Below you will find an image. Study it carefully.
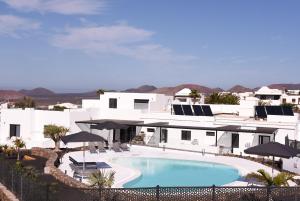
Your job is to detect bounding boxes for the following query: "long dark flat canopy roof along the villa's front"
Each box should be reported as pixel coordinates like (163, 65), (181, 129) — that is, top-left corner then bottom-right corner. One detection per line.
(76, 119), (278, 134)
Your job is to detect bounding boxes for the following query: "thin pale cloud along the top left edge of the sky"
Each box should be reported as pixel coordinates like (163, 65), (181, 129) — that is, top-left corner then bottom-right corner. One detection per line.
(0, 0), (105, 15)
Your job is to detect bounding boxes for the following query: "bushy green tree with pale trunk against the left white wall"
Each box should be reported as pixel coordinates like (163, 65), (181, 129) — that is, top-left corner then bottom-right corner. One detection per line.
(44, 124), (69, 151)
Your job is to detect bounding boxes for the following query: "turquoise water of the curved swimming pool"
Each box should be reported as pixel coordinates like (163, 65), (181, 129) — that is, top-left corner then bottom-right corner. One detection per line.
(113, 158), (240, 188)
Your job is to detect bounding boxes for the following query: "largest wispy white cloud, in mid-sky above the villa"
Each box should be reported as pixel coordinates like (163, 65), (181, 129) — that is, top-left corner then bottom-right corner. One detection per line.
(50, 24), (195, 62)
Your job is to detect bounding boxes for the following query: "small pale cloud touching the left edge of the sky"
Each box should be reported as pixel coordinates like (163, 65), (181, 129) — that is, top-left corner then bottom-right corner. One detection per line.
(0, 15), (40, 38)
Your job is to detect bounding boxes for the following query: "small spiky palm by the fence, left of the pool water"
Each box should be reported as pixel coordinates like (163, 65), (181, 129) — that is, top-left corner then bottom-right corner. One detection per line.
(89, 170), (116, 189)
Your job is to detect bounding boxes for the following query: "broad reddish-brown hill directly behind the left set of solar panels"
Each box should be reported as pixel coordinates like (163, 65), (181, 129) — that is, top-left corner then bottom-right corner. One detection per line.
(152, 84), (222, 95)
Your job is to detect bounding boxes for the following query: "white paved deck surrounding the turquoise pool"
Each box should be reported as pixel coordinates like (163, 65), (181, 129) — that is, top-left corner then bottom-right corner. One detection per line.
(59, 146), (278, 188)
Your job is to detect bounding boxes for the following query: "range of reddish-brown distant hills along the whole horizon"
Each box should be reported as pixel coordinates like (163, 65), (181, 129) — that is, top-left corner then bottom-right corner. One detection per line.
(0, 84), (300, 106)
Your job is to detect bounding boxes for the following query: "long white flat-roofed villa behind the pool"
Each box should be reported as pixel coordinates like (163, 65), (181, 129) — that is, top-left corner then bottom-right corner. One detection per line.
(0, 89), (300, 174)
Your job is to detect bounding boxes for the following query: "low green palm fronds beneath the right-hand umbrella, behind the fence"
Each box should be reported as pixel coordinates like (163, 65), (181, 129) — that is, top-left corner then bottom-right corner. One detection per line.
(246, 169), (293, 186)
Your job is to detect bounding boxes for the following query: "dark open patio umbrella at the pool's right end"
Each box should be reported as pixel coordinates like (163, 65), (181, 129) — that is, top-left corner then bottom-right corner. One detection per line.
(244, 142), (299, 177)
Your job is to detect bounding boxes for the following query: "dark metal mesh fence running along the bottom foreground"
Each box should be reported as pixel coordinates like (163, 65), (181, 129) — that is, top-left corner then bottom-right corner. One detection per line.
(0, 161), (300, 201)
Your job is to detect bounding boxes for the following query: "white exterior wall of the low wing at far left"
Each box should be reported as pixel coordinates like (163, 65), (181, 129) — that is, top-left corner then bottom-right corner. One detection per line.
(0, 108), (89, 148)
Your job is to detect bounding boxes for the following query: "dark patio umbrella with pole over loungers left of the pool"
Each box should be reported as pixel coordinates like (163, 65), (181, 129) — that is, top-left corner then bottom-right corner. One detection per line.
(61, 131), (105, 181)
